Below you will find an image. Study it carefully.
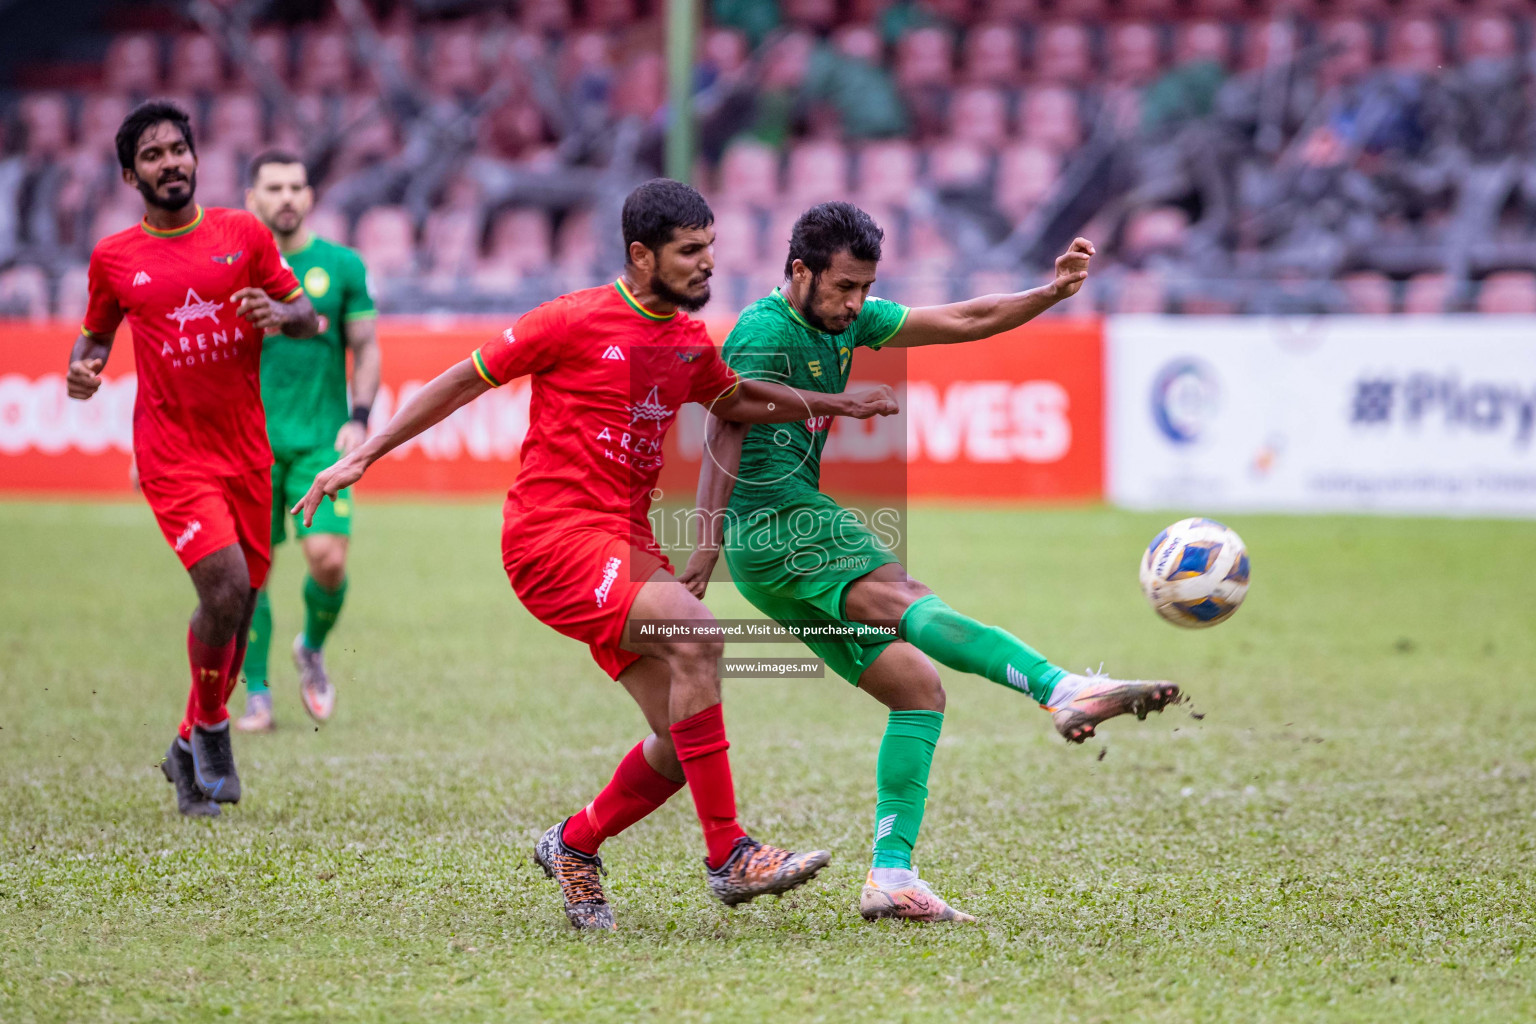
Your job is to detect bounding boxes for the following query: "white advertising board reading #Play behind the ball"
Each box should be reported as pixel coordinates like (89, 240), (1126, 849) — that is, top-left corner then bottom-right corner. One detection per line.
(1106, 316), (1536, 516)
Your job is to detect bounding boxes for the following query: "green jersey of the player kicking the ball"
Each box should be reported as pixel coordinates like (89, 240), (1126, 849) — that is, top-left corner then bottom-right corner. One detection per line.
(720, 289), (908, 517)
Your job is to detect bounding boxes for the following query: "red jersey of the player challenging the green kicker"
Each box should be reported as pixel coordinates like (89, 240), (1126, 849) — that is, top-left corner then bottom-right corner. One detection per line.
(473, 281), (737, 536)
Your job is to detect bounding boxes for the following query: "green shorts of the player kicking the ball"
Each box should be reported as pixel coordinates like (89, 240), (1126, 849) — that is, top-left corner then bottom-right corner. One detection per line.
(723, 493), (899, 686)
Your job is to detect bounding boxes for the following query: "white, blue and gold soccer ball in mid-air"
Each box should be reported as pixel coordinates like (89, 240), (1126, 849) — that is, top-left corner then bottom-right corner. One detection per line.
(1141, 519), (1249, 629)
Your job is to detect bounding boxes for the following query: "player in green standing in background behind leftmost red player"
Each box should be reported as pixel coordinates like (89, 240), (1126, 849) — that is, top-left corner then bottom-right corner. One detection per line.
(235, 150), (379, 732)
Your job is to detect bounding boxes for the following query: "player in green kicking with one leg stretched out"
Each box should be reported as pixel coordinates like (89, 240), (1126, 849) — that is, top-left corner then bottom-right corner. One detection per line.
(691, 203), (1178, 921)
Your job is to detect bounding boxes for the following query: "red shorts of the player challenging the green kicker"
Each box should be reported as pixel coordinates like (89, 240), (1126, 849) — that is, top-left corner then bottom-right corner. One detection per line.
(501, 519), (673, 679)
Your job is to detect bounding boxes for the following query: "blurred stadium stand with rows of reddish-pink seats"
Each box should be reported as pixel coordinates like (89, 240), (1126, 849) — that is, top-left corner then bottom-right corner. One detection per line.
(0, 0), (1536, 318)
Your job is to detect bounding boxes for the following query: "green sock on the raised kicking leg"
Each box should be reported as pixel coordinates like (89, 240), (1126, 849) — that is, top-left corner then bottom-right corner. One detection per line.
(900, 594), (1066, 703)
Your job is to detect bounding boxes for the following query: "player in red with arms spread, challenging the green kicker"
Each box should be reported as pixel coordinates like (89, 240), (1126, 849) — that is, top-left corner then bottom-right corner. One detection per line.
(295, 178), (895, 929)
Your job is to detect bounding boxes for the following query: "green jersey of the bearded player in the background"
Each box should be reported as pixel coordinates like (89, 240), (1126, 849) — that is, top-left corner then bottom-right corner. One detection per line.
(261, 235), (375, 451)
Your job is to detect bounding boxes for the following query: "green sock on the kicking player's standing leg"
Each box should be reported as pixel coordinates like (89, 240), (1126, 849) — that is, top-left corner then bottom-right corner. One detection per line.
(869, 711), (945, 867)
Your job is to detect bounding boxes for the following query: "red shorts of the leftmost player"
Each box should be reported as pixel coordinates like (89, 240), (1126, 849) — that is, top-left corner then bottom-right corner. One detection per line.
(140, 468), (272, 586)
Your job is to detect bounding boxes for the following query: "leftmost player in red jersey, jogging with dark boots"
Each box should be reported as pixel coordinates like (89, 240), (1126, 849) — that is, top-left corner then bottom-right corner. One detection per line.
(68, 103), (319, 817)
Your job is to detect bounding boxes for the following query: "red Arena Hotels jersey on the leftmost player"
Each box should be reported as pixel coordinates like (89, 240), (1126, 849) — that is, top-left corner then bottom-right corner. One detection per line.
(81, 207), (303, 479)
